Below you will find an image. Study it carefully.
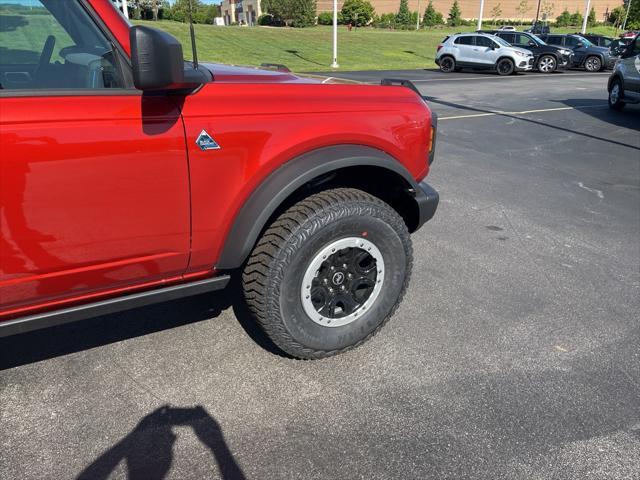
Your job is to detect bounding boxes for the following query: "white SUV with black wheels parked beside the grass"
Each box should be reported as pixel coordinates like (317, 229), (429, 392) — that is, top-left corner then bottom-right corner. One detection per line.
(436, 33), (533, 75)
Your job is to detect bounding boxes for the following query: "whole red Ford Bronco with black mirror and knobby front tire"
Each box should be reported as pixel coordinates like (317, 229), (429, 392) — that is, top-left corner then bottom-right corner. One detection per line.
(0, 0), (438, 358)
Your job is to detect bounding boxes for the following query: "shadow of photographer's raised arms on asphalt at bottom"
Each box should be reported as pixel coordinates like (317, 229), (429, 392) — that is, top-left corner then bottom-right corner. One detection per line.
(76, 405), (246, 480)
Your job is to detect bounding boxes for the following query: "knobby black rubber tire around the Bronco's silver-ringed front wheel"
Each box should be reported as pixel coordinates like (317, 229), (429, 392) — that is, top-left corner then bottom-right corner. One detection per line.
(242, 188), (413, 359)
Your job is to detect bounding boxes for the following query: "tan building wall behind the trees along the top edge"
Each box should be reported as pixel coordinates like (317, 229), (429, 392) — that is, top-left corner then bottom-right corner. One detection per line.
(317, 0), (622, 23)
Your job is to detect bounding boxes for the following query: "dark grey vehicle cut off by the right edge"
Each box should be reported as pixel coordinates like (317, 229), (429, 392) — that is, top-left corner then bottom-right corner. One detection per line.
(608, 35), (640, 110)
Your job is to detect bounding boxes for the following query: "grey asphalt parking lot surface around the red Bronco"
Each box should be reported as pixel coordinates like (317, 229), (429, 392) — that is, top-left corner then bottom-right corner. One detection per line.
(0, 71), (640, 480)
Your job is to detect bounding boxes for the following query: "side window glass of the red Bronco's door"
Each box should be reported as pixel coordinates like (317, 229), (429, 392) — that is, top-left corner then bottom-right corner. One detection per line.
(0, 0), (123, 90)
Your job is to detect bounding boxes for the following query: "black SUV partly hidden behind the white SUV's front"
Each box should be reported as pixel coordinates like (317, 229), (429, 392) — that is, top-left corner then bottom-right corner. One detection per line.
(481, 30), (573, 73)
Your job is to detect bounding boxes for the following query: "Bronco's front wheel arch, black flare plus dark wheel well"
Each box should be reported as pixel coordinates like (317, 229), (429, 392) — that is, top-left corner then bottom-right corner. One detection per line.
(216, 145), (427, 270)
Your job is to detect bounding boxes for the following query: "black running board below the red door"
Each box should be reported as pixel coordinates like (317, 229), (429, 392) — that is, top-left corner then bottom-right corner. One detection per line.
(0, 275), (230, 337)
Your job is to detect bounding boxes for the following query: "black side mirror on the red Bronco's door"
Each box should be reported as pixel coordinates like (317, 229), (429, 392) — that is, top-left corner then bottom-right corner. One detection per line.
(129, 25), (198, 91)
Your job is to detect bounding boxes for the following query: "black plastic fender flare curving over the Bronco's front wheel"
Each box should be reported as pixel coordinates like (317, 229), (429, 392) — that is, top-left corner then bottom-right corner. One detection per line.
(216, 145), (420, 270)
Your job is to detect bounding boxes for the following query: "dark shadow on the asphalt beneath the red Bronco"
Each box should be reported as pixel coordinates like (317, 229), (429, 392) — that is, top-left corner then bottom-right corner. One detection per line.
(0, 282), (284, 371)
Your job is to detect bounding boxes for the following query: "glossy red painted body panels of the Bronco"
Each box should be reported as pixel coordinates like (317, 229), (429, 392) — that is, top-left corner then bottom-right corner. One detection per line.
(0, 0), (431, 318)
